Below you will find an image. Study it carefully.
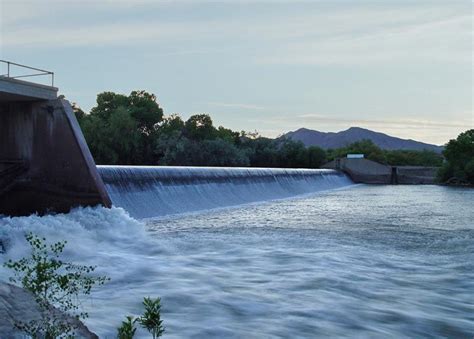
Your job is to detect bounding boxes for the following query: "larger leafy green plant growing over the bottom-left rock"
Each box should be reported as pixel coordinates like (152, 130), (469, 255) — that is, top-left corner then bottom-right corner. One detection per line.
(4, 233), (110, 339)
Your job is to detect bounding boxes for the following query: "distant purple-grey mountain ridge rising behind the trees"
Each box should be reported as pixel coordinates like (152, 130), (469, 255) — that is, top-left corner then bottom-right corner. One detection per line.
(284, 127), (443, 153)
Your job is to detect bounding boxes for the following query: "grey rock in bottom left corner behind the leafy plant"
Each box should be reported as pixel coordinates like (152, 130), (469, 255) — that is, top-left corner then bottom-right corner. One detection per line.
(0, 281), (98, 339)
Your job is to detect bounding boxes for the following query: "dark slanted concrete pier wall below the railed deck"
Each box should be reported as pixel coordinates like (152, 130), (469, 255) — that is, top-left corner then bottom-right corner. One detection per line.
(0, 99), (111, 215)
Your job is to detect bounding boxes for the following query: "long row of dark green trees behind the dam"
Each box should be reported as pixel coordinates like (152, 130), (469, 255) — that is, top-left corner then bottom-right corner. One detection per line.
(73, 91), (473, 185)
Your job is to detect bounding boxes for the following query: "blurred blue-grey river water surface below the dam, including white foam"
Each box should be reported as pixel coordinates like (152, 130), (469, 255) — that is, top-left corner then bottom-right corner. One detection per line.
(0, 185), (474, 338)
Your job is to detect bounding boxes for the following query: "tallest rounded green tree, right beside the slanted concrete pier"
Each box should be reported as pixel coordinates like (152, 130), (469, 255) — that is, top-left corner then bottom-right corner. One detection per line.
(79, 91), (163, 165)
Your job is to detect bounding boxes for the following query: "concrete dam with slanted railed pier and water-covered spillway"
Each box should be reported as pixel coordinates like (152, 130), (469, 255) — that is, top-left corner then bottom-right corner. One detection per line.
(0, 60), (352, 218)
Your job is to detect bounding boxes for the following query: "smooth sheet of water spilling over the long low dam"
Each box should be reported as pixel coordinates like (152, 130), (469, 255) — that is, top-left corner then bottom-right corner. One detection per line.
(97, 166), (353, 218)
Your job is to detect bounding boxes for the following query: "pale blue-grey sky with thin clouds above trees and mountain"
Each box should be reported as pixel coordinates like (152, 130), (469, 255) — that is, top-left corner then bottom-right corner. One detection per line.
(0, 0), (474, 144)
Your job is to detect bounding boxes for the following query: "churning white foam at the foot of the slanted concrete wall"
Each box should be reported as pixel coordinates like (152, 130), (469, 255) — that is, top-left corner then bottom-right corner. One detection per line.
(0, 207), (150, 280)
